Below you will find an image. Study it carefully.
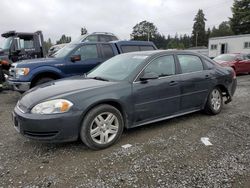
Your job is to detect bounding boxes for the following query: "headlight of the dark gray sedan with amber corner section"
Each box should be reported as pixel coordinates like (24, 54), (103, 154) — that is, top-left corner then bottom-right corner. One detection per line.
(31, 99), (73, 114)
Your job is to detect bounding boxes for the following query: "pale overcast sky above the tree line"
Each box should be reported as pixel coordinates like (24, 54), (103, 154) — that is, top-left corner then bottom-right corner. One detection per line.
(0, 0), (233, 42)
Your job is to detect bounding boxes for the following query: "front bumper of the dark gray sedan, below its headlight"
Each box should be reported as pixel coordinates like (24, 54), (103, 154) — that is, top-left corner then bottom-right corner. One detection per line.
(12, 107), (81, 142)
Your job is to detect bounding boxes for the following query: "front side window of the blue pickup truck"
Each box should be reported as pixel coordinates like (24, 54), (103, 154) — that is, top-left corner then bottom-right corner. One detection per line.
(74, 44), (98, 60)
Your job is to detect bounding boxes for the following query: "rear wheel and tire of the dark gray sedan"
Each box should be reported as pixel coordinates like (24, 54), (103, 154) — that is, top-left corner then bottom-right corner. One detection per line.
(204, 87), (223, 115)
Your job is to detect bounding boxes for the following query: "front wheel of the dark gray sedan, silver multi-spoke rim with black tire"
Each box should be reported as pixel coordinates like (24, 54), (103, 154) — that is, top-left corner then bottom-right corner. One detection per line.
(80, 104), (124, 150)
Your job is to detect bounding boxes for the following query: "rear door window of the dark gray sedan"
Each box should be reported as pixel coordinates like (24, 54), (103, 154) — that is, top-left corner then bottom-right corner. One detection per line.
(177, 55), (203, 73)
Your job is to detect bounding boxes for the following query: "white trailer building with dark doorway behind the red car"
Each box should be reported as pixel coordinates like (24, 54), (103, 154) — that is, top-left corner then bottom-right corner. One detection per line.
(208, 34), (250, 58)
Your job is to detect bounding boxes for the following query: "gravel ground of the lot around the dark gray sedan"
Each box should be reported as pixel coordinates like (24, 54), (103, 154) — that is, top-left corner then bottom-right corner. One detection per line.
(0, 75), (250, 188)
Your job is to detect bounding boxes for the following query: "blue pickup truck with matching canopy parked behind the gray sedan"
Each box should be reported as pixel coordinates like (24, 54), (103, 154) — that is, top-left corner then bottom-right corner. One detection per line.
(8, 41), (157, 92)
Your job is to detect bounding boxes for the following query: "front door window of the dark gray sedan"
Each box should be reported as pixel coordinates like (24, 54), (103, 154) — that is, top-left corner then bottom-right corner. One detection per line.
(144, 55), (175, 77)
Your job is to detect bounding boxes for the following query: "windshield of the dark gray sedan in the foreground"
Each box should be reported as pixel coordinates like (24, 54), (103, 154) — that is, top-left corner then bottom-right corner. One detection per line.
(87, 54), (148, 81)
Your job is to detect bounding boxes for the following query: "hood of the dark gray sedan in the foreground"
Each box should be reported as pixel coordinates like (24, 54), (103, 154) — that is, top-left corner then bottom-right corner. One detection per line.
(19, 76), (116, 108)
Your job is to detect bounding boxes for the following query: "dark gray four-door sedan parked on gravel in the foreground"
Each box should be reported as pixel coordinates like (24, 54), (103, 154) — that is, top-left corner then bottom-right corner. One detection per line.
(13, 51), (236, 149)
